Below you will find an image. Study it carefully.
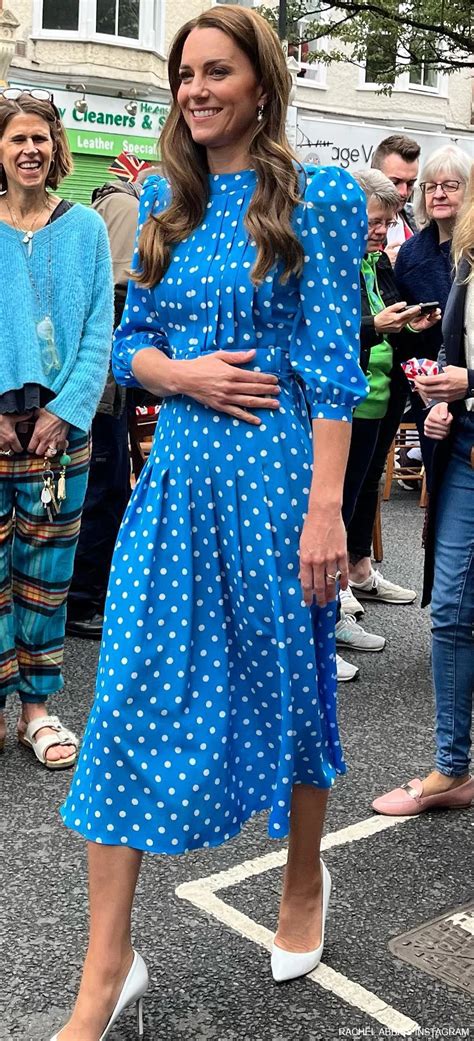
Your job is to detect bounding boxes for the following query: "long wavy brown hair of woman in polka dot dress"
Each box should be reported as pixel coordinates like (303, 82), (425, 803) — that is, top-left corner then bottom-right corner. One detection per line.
(136, 5), (304, 287)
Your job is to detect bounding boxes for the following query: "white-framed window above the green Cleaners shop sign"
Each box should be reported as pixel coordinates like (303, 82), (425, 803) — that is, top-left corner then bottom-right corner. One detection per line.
(33, 0), (165, 50)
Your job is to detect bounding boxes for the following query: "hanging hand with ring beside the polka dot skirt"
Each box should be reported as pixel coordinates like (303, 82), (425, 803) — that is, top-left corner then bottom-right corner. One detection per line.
(299, 507), (349, 607)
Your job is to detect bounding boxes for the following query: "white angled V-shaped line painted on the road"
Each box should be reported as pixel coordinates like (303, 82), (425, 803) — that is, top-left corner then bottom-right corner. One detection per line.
(176, 816), (420, 1037)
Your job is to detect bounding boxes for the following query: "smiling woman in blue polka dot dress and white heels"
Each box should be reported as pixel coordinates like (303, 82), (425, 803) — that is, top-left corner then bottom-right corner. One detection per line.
(55, 6), (367, 1041)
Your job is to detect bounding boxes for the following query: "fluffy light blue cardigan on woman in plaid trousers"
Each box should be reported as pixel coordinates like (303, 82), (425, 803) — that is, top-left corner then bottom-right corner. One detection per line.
(0, 204), (114, 431)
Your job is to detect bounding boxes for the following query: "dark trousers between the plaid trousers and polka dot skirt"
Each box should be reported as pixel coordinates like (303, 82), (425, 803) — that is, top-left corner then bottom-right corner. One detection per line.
(68, 410), (130, 621)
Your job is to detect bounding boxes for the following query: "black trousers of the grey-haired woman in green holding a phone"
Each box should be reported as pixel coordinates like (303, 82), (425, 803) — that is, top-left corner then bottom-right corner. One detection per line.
(347, 363), (408, 563)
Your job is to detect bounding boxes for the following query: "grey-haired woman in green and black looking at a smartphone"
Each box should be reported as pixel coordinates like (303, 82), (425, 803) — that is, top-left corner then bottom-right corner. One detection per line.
(336, 170), (441, 641)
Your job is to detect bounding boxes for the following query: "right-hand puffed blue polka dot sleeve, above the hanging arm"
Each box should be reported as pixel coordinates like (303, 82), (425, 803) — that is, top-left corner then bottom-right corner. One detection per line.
(291, 167), (369, 423)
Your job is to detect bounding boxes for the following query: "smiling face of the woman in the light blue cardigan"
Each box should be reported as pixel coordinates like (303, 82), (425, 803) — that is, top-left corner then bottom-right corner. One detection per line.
(0, 112), (54, 191)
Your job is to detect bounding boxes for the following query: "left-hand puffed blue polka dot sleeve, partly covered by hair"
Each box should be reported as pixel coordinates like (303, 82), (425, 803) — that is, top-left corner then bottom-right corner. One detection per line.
(111, 177), (170, 387)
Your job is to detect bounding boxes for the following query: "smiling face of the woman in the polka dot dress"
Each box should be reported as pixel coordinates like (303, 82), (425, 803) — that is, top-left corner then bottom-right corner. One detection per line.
(178, 29), (266, 164)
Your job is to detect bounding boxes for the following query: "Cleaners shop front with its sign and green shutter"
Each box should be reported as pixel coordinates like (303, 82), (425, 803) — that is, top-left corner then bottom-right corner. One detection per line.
(10, 82), (169, 204)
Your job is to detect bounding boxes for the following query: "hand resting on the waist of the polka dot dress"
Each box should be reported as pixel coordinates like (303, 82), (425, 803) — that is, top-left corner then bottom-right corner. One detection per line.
(178, 350), (279, 427)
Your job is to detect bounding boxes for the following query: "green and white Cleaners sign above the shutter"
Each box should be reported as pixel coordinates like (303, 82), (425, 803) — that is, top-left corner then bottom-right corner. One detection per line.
(10, 83), (169, 160)
